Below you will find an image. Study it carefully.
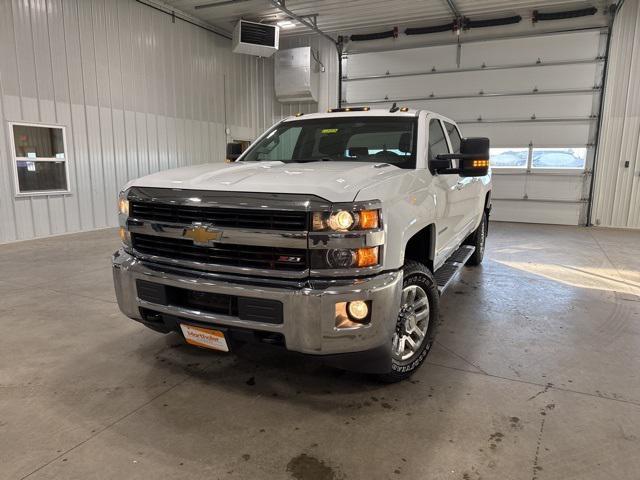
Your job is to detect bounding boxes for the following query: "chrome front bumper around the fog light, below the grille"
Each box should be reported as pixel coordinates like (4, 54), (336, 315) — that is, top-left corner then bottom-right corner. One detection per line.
(113, 249), (402, 365)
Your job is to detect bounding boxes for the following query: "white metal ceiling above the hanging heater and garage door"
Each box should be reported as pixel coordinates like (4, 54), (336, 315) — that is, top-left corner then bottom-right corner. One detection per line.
(158, 0), (610, 36)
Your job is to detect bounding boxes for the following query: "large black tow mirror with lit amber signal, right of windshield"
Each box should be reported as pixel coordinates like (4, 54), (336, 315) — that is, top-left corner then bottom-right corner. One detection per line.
(431, 137), (489, 177)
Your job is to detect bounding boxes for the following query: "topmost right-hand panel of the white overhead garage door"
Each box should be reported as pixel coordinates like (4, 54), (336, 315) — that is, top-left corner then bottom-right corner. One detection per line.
(460, 31), (601, 68)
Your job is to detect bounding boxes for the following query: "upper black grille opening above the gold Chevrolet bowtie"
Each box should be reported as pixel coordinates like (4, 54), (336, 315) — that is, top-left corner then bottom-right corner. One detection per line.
(129, 201), (308, 231)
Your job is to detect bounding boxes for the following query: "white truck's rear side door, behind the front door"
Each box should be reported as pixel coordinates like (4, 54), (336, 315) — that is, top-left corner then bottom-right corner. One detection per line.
(442, 121), (484, 243)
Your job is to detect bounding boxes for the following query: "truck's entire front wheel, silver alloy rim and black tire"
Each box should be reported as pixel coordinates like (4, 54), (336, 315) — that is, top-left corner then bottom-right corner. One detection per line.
(381, 260), (439, 383)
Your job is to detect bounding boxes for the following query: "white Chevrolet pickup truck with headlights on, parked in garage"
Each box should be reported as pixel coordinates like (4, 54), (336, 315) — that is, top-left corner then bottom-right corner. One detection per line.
(113, 105), (491, 381)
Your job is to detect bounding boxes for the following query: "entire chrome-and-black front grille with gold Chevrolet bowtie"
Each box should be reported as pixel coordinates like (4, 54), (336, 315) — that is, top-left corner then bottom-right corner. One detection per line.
(125, 187), (331, 279)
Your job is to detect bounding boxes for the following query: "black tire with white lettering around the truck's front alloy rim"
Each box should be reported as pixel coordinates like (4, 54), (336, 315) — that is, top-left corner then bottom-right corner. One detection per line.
(379, 260), (440, 383)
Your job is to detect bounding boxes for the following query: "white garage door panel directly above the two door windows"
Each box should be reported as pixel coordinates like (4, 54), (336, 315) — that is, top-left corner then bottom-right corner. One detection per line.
(460, 122), (592, 148)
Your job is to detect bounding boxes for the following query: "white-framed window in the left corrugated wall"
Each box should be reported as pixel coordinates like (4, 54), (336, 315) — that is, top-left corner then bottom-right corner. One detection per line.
(10, 123), (69, 195)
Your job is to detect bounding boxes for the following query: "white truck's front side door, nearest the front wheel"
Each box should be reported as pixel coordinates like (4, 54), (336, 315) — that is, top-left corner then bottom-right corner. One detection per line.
(427, 118), (465, 266)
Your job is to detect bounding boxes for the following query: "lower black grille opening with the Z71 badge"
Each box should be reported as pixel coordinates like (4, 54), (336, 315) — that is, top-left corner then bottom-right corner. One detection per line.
(131, 233), (309, 272)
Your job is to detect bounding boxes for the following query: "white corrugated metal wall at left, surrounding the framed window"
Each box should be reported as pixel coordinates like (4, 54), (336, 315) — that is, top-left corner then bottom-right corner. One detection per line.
(0, 0), (281, 243)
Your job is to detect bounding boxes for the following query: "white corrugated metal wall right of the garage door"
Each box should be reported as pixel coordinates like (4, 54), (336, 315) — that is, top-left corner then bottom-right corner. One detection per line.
(591, 0), (640, 228)
